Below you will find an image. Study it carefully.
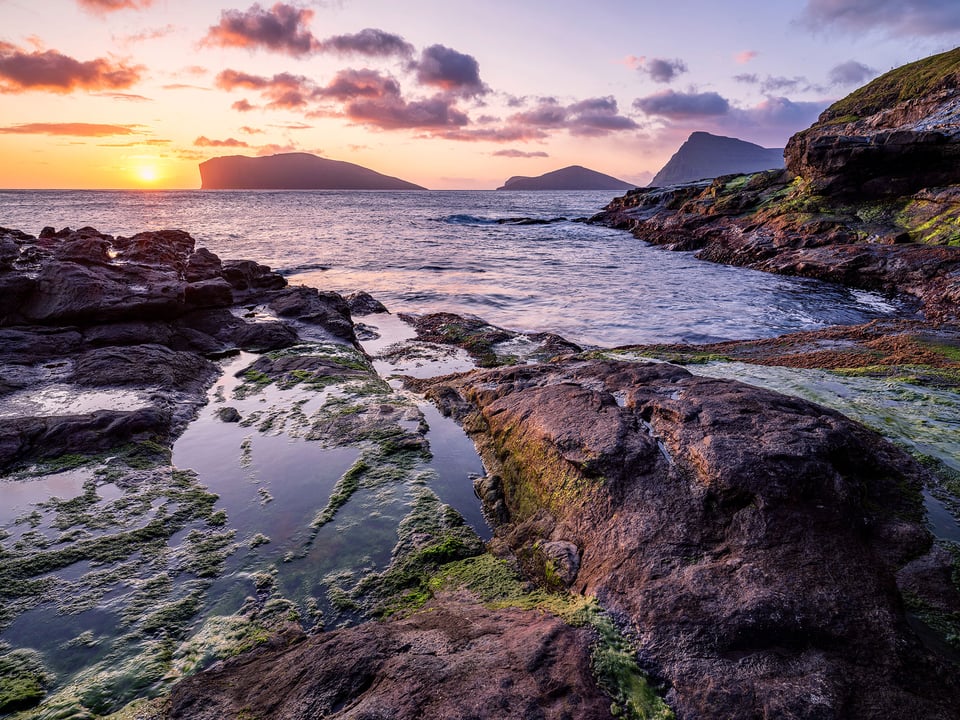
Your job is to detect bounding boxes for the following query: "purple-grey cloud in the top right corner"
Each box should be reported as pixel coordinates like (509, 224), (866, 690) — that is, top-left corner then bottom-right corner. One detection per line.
(801, 0), (960, 37)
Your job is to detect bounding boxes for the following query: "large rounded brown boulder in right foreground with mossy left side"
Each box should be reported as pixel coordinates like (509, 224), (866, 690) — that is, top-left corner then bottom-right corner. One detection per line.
(429, 360), (960, 720)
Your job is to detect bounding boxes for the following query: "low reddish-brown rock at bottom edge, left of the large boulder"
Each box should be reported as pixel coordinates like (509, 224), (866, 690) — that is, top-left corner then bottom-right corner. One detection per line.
(168, 593), (612, 720)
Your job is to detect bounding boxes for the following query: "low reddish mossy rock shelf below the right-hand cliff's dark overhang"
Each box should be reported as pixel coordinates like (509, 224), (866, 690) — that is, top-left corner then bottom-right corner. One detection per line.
(592, 171), (960, 323)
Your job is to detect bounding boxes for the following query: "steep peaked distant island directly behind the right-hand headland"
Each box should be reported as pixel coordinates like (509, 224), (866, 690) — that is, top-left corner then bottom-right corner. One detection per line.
(650, 132), (784, 187)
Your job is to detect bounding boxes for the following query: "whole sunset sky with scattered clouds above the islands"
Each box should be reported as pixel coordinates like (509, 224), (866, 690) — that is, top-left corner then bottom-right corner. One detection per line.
(0, 0), (960, 189)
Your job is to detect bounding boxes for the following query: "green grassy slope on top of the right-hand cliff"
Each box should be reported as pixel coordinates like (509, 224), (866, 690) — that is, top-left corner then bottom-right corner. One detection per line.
(817, 48), (960, 125)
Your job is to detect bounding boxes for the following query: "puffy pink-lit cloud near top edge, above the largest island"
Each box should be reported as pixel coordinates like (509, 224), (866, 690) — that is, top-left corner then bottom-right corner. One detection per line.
(203, 2), (320, 57)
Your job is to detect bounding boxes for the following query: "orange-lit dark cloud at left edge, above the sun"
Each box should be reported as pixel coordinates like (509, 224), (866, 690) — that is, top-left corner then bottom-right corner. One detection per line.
(0, 42), (143, 93)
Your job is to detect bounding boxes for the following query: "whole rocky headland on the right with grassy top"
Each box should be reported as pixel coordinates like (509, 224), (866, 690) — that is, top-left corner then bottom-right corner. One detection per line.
(592, 49), (960, 322)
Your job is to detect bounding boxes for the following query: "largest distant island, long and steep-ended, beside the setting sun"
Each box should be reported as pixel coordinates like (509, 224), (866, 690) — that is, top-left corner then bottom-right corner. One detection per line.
(200, 153), (426, 190)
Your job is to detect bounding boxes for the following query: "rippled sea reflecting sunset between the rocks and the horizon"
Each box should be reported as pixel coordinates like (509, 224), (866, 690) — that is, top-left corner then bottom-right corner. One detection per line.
(0, 190), (897, 345)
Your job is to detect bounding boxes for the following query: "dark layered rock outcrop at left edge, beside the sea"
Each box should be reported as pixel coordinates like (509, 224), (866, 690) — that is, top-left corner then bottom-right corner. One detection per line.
(0, 227), (356, 468)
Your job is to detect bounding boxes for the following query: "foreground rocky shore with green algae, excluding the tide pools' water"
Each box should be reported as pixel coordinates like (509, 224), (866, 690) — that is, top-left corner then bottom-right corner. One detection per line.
(0, 219), (960, 718)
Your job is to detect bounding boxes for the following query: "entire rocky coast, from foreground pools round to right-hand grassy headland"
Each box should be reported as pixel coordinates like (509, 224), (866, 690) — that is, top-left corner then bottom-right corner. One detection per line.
(0, 46), (960, 720)
